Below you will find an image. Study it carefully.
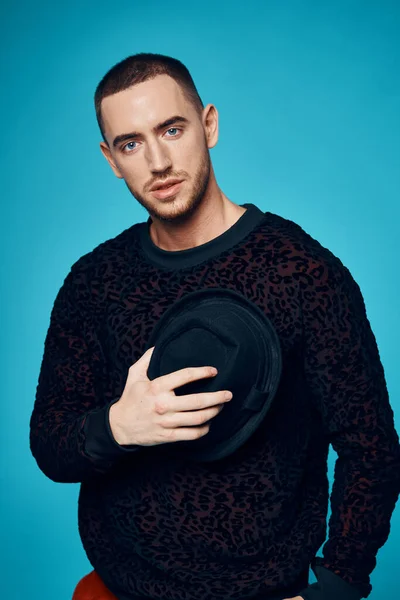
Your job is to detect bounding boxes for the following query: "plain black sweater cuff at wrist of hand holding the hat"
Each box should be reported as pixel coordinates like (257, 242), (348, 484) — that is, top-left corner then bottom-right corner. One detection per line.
(84, 397), (142, 461)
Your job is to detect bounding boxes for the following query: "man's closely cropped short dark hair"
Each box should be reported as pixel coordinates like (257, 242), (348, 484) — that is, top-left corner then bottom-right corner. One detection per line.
(94, 52), (204, 143)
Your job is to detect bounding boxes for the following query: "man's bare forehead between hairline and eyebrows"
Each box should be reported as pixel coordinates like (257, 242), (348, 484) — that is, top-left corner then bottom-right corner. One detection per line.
(101, 75), (194, 135)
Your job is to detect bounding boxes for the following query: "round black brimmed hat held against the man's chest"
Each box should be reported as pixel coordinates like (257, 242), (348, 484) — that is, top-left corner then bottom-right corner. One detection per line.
(146, 287), (282, 462)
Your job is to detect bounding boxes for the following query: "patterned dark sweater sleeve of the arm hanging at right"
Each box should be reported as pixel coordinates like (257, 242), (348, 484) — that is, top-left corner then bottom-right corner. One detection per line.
(299, 259), (400, 598)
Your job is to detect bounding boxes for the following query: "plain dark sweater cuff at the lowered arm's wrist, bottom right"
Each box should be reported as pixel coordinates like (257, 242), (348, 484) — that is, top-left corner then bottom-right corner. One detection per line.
(298, 566), (362, 600)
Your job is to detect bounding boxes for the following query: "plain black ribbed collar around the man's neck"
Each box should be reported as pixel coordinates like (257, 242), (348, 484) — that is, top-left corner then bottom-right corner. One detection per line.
(139, 203), (266, 269)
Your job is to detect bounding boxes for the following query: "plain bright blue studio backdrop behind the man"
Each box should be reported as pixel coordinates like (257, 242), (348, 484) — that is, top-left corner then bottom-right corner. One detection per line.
(0, 0), (400, 600)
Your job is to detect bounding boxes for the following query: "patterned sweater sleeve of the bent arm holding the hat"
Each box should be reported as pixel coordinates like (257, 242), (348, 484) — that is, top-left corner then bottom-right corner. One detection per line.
(30, 261), (140, 483)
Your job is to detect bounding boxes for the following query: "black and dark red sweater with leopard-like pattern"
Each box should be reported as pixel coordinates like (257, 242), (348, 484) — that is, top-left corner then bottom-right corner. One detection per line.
(30, 204), (400, 600)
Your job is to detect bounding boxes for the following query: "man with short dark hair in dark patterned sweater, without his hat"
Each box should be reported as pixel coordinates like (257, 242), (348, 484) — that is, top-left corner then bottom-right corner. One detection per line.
(31, 54), (400, 600)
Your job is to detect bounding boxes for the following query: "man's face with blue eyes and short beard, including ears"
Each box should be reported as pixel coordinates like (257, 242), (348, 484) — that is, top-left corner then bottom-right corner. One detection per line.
(100, 75), (218, 222)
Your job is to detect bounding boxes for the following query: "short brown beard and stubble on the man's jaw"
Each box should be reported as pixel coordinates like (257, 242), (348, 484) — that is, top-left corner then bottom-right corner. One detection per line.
(124, 146), (211, 223)
